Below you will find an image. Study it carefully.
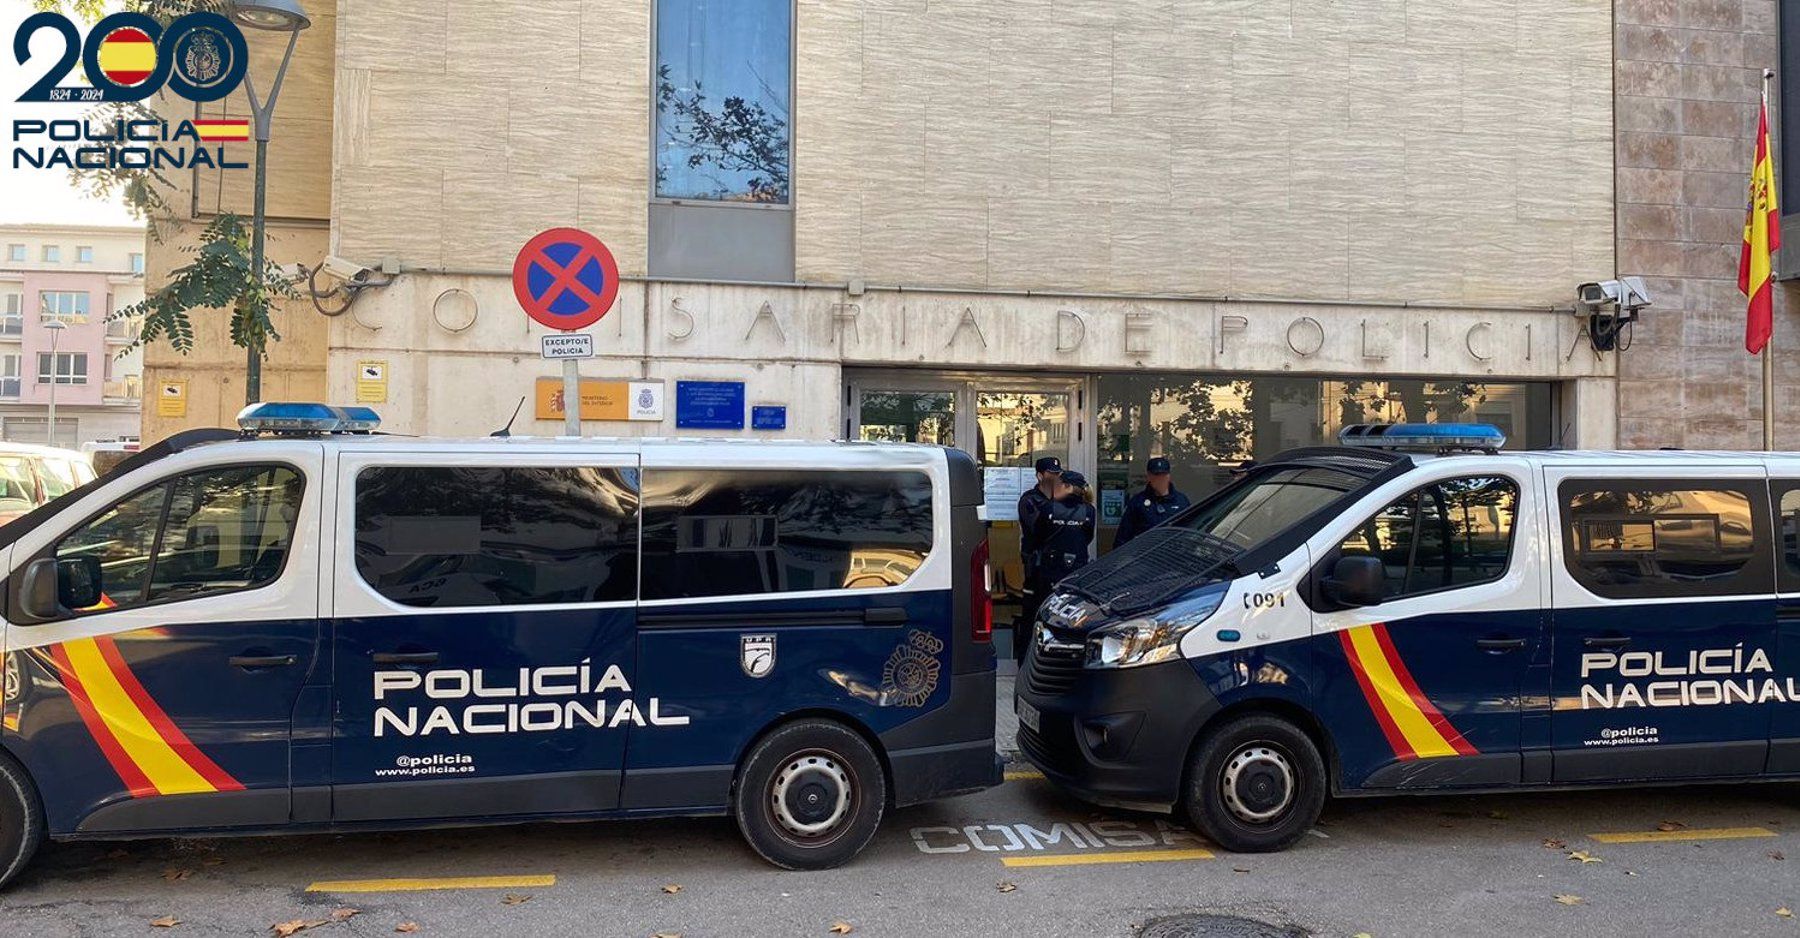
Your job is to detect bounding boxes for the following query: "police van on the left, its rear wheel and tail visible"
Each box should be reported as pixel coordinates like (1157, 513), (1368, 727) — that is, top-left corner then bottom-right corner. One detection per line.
(0, 403), (1001, 882)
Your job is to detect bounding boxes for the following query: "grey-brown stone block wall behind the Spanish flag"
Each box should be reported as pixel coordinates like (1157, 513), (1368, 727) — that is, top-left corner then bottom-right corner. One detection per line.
(1616, 0), (1800, 448)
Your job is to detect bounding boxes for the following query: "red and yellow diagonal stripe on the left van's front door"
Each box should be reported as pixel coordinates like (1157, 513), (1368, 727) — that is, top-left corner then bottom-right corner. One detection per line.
(49, 637), (243, 798)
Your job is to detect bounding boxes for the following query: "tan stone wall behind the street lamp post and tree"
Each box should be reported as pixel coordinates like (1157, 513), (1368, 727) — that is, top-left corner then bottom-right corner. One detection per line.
(142, 4), (338, 443)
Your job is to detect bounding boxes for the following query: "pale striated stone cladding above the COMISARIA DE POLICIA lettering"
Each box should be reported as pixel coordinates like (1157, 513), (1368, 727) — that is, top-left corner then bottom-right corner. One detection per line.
(333, 0), (1613, 304)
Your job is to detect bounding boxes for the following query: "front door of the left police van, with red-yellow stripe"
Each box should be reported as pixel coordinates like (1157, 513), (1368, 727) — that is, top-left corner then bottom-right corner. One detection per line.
(4, 441), (324, 834)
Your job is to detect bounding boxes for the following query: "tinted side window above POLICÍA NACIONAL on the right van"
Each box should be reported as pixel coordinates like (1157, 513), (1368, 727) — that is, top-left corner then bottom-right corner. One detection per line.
(1561, 481), (1771, 600)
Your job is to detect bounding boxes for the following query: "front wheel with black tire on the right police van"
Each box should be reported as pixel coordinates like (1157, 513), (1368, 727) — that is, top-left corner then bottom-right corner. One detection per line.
(1183, 715), (1327, 853)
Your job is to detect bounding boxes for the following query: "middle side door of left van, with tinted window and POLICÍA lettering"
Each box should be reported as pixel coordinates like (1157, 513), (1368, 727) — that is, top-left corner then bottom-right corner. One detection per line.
(331, 445), (643, 823)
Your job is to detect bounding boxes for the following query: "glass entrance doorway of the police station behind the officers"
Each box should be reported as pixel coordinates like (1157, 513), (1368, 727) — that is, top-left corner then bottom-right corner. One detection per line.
(844, 371), (1093, 661)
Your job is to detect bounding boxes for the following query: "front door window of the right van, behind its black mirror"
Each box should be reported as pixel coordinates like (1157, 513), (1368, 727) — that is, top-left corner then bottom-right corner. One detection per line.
(1341, 475), (1519, 600)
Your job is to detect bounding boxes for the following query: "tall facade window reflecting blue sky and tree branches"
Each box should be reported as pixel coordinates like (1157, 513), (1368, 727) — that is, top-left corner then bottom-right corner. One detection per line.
(652, 0), (794, 205)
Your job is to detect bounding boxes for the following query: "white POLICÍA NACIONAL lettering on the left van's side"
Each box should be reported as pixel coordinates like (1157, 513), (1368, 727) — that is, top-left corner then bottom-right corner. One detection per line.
(374, 659), (688, 736)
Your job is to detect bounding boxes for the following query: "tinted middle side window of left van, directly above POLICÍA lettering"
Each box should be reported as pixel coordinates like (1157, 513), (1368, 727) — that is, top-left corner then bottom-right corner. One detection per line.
(356, 466), (637, 607)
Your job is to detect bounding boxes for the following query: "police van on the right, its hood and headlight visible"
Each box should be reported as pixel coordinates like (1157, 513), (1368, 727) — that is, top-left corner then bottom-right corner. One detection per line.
(1015, 425), (1800, 852)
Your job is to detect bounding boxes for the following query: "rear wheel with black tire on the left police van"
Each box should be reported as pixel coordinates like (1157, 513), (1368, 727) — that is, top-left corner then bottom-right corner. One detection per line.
(731, 720), (887, 870)
